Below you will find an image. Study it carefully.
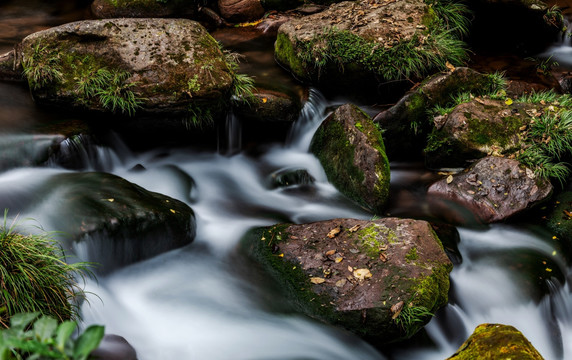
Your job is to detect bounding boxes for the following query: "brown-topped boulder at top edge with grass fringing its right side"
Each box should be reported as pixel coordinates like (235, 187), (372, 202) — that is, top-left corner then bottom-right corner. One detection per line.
(275, 0), (468, 87)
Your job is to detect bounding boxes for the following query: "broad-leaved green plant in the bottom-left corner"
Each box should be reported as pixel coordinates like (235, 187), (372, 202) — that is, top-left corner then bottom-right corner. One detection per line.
(0, 312), (104, 360)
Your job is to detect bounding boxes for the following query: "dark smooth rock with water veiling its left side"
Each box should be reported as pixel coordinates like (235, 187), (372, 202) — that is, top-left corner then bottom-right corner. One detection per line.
(39, 172), (195, 273)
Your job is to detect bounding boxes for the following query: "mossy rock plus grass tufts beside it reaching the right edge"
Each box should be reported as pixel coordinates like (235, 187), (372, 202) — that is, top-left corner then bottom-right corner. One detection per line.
(425, 91), (572, 184)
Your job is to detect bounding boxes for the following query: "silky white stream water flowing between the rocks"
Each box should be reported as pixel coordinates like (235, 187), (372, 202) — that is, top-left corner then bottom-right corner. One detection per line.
(0, 1), (572, 360)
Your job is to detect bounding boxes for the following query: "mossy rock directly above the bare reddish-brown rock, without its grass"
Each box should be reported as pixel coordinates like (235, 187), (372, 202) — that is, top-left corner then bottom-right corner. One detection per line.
(425, 98), (539, 168)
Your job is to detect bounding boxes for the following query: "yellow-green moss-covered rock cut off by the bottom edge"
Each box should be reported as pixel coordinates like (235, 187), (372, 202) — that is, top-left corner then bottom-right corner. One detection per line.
(447, 324), (544, 360)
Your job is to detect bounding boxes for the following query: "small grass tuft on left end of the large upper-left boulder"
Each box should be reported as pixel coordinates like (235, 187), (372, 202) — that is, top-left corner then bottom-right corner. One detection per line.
(22, 42), (63, 90)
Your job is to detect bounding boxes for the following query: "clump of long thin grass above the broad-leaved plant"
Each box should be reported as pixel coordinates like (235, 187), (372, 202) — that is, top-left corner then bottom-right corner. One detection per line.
(0, 210), (92, 327)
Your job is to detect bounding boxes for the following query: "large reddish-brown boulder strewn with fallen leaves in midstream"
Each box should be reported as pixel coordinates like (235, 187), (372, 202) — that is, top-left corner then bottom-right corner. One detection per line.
(243, 218), (452, 344)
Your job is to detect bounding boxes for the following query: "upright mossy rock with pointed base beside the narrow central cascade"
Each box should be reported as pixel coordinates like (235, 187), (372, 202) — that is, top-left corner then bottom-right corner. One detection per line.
(310, 104), (390, 212)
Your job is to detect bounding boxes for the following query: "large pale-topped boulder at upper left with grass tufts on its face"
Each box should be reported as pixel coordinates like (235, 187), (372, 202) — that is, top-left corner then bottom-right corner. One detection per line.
(21, 19), (234, 123)
